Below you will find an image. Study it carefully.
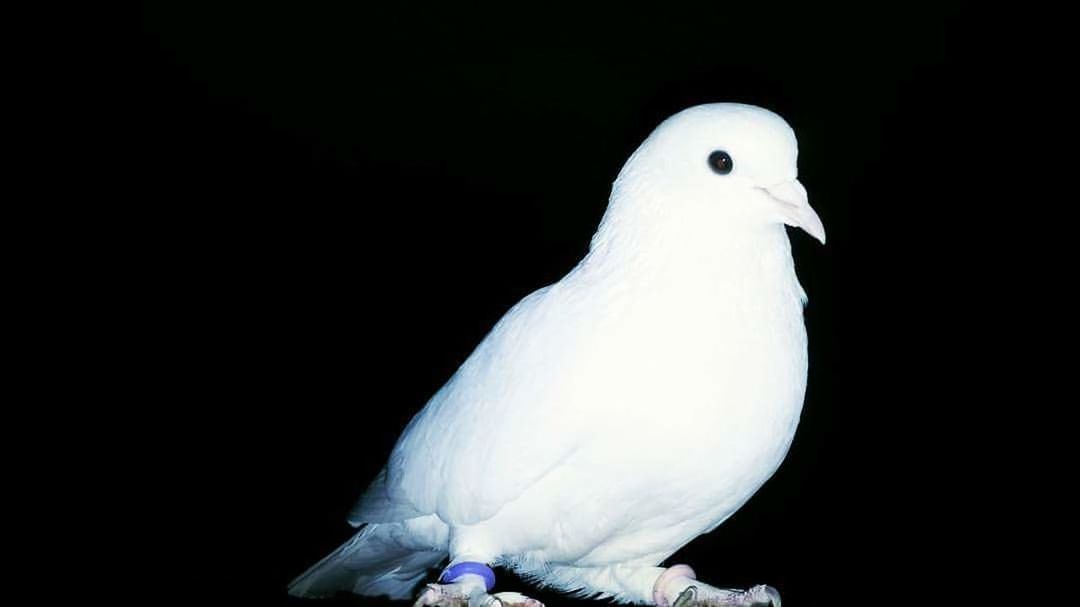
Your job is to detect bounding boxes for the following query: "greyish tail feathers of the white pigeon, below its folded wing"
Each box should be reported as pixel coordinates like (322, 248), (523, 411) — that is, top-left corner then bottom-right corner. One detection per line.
(288, 525), (446, 599)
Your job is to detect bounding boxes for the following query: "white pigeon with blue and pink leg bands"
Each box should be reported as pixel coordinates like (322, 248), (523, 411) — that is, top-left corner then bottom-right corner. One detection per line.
(288, 103), (825, 607)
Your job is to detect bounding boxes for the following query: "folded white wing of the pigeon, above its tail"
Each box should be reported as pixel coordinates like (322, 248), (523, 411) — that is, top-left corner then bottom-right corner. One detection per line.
(349, 284), (589, 525)
